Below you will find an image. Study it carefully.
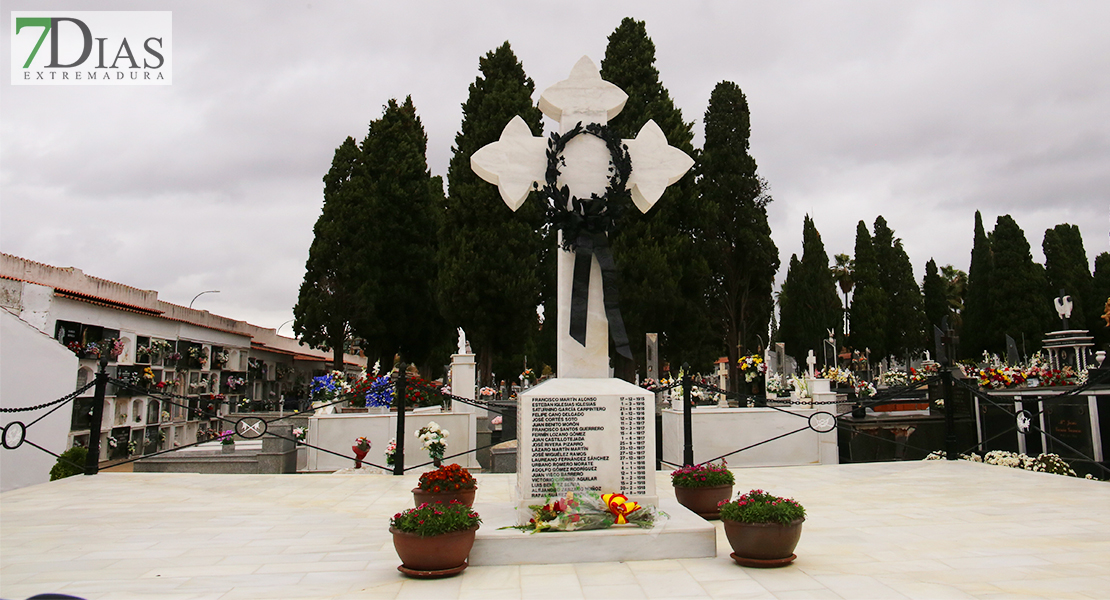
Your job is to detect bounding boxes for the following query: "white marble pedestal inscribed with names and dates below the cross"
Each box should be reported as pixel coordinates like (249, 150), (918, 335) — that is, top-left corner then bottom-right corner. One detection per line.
(516, 377), (658, 520)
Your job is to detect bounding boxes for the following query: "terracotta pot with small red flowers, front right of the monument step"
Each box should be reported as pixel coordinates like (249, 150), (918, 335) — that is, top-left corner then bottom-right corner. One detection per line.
(720, 489), (806, 567)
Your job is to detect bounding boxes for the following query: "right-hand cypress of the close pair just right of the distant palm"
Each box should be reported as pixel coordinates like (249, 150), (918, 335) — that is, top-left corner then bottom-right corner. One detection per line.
(874, 215), (925, 359)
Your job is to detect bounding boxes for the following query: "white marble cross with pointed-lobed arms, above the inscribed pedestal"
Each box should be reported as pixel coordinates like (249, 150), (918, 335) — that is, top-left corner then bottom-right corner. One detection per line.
(471, 57), (694, 378)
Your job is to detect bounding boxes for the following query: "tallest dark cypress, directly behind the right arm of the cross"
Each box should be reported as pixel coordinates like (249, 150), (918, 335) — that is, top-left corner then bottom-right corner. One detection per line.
(601, 18), (723, 379)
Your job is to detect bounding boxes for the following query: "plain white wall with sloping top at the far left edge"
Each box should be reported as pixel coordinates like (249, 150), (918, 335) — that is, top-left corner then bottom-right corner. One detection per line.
(0, 309), (78, 491)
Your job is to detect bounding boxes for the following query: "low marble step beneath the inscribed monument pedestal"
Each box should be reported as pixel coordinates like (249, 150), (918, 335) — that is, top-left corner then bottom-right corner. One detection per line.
(470, 498), (717, 567)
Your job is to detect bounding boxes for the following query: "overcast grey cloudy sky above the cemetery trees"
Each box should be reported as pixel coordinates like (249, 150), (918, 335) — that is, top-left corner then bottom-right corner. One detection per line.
(0, 0), (1110, 334)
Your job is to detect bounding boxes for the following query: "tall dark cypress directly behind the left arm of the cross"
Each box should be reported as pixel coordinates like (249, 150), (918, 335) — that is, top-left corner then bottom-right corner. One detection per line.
(437, 42), (555, 383)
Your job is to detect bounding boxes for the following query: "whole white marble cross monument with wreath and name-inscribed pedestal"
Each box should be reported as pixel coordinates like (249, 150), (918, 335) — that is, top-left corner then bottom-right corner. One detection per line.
(471, 57), (694, 512)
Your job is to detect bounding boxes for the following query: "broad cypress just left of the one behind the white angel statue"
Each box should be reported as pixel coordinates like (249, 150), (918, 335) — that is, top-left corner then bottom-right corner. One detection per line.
(986, 215), (1051, 356)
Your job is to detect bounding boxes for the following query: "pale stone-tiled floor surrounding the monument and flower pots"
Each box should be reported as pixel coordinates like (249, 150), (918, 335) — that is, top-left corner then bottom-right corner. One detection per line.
(0, 461), (1110, 600)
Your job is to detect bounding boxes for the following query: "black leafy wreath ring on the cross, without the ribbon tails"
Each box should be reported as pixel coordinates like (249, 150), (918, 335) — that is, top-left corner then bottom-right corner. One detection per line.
(543, 121), (632, 252)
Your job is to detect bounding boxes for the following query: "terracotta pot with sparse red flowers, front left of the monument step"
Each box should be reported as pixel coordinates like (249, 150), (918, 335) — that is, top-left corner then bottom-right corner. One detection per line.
(390, 500), (482, 578)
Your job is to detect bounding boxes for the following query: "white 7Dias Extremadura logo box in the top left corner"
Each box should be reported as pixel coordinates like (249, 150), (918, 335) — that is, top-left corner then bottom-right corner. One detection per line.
(11, 11), (173, 85)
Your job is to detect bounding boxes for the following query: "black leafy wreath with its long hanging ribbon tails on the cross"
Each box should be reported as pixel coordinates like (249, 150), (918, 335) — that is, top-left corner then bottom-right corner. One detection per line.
(543, 121), (632, 360)
